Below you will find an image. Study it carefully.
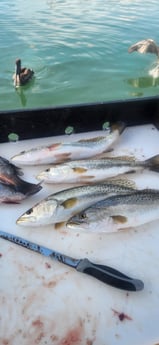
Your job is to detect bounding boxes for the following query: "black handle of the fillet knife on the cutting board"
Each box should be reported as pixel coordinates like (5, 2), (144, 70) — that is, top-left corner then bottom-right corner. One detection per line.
(76, 259), (144, 291)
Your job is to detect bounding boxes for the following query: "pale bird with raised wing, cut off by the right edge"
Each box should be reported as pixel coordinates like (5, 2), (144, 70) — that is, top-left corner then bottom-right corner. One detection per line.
(128, 38), (159, 78)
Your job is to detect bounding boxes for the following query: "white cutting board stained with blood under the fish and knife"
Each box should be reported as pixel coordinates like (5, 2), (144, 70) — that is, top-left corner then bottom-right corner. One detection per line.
(0, 125), (159, 345)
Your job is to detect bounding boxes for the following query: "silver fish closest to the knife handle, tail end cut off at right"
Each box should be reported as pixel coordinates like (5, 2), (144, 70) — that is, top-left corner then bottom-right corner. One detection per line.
(66, 189), (159, 233)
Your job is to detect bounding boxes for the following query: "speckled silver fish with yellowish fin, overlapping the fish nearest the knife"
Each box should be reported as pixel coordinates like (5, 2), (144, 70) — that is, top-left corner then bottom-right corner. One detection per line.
(16, 179), (136, 228)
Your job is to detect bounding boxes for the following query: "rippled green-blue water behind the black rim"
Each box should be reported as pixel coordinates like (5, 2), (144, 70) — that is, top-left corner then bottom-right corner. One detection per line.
(0, 0), (159, 110)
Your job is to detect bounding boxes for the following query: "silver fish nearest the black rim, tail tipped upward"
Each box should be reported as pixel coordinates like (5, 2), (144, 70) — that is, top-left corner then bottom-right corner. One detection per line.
(11, 122), (125, 165)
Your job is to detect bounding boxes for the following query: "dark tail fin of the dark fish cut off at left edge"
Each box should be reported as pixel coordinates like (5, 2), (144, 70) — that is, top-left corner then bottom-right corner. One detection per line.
(16, 179), (42, 196)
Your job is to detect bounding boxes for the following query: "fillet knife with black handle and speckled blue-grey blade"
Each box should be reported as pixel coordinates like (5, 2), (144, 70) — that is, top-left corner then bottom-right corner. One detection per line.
(0, 231), (144, 291)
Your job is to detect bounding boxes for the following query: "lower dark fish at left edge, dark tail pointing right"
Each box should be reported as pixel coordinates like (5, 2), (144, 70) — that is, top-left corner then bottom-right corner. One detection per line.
(0, 182), (42, 204)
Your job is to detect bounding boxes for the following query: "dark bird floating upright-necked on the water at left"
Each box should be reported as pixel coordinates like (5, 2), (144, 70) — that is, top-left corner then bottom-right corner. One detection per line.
(13, 59), (34, 87)
